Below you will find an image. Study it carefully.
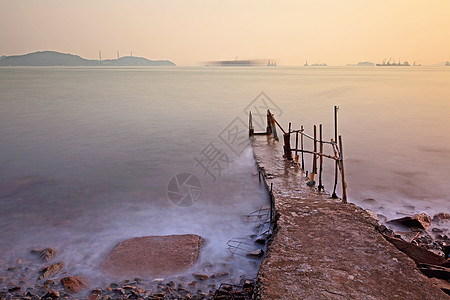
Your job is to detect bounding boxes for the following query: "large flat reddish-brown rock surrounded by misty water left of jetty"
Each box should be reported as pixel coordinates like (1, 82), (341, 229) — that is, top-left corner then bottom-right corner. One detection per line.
(102, 234), (204, 277)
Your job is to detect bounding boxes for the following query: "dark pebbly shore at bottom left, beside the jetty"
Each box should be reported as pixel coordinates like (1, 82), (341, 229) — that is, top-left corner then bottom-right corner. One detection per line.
(0, 243), (254, 300)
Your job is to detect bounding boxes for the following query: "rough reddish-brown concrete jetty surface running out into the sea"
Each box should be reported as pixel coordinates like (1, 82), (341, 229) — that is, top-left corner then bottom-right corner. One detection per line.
(252, 136), (450, 300)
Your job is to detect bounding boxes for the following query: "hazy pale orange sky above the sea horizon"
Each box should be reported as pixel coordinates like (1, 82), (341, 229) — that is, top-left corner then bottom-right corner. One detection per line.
(0, 0), (450, 66)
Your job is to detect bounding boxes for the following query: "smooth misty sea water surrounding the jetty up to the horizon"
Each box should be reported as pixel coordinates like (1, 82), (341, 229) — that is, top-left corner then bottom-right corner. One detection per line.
(0, 67), (450, 284)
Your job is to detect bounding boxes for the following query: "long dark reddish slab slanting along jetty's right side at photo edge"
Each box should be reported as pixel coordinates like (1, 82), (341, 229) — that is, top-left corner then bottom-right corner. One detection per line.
(383, 235), (447, 265)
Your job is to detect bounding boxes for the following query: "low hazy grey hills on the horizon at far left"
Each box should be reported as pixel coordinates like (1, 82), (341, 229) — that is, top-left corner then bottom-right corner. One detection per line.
(0, 51), (175, 66)
